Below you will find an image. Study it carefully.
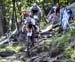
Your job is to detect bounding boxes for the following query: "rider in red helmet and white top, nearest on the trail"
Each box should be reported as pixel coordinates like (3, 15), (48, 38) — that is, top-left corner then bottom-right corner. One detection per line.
(22, 12), (37, 46)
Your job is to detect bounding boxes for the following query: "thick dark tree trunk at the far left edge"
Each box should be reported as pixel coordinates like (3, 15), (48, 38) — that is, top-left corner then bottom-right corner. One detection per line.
(0, 1), (7, 36)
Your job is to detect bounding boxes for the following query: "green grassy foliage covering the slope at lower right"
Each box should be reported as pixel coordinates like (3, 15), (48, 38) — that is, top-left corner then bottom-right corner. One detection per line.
(41, 19), (75, 59)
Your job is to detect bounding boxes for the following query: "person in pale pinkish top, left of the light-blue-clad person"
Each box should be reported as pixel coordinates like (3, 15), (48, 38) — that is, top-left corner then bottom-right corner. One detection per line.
(48, 7), (60, 24)
